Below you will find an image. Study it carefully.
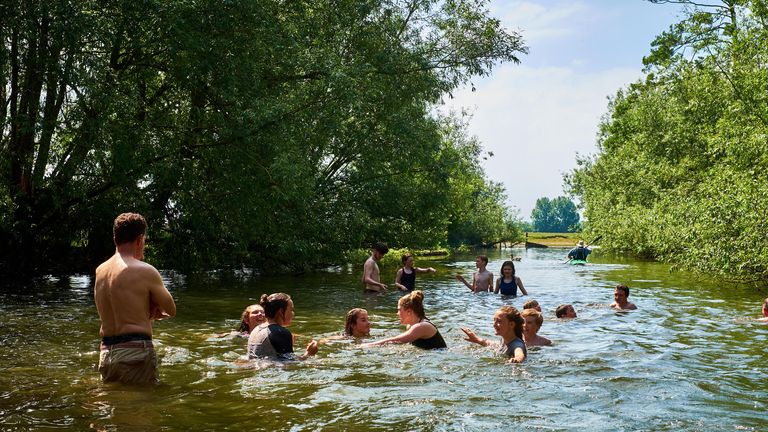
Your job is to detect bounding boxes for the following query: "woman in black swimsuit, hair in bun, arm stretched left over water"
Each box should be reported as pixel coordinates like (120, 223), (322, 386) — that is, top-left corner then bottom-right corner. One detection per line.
(363, 290), (447, 349)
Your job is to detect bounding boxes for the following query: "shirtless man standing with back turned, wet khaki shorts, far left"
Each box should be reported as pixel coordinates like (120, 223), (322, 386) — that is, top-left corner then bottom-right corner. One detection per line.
(93, 213), (176, 384)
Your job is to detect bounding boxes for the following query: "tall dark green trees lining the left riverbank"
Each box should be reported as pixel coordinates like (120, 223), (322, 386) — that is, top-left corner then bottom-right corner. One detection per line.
(0, 0), (526, 274)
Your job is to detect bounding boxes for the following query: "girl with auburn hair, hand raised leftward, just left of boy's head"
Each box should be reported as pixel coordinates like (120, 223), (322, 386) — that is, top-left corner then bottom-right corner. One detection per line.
(461, 306), (528, 363)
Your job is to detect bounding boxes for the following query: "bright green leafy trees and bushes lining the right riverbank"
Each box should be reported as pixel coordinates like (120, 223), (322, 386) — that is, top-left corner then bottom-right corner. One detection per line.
(566, 1), (768, 281)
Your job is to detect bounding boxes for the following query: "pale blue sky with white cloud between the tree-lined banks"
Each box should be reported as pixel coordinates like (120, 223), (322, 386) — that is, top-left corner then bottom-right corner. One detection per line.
(445, 0), (682, 220)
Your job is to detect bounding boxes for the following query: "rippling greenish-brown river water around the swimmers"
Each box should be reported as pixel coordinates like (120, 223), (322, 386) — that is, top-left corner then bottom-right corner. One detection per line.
(0, 249), (768, 431)
